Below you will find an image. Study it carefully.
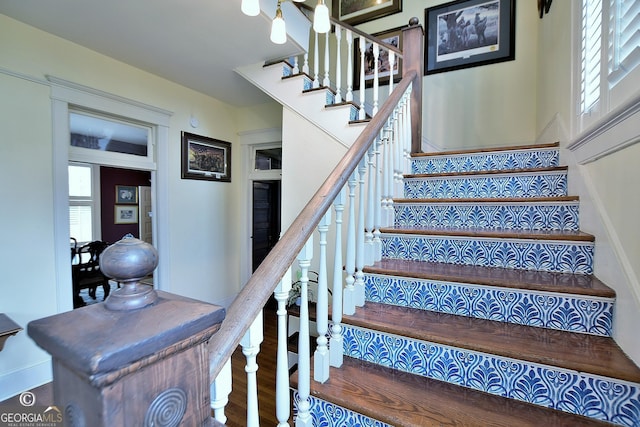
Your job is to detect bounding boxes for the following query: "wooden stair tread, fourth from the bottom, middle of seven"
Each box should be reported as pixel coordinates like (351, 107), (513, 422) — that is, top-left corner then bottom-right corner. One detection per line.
(380, 226), (595, 242)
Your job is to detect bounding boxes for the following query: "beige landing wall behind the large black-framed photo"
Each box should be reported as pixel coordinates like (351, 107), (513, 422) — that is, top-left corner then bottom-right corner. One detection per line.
(358, 0), (540, 151)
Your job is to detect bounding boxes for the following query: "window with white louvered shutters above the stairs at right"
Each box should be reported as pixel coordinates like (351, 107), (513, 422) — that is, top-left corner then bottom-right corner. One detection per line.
(578, 0), (640, 129)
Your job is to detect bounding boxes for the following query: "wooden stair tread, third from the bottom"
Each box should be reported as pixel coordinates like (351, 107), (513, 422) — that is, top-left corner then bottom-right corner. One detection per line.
(364, 259), (616, 298)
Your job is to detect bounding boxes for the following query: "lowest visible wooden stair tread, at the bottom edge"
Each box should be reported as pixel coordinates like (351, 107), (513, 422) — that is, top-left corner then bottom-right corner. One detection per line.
(291, 357), (610, 427)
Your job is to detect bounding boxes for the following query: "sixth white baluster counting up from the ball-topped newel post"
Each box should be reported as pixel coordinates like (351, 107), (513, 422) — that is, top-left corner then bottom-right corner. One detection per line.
(329, 188), (345, 368)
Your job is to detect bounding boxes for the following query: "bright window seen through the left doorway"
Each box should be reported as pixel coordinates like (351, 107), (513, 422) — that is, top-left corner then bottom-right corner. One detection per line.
(69, 163), (98, 242)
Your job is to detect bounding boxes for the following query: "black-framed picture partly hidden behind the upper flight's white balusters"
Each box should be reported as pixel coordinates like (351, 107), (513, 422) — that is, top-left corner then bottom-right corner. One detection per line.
(353, 27), (403, 89)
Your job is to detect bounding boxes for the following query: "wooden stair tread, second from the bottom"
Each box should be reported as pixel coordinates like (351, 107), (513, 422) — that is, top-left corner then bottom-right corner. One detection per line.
(343, 302), (640, 382)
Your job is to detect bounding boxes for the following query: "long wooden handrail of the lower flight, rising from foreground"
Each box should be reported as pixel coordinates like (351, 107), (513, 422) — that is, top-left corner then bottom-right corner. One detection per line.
(209, 71), (421, 380)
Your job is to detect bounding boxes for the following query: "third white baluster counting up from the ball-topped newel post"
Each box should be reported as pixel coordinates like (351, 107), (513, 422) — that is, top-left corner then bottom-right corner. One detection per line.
(273, 267), (291, 427)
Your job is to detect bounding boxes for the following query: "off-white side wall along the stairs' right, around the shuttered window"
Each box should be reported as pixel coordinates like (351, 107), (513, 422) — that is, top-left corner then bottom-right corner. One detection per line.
(536, 2), (640, 364)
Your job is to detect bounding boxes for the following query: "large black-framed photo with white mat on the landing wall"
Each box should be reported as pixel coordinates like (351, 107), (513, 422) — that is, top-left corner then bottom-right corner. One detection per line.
(424, 0), (515, 75)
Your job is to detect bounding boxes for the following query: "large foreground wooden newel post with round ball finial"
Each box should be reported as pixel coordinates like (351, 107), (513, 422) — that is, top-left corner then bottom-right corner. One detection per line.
(27, 237), (225, 427)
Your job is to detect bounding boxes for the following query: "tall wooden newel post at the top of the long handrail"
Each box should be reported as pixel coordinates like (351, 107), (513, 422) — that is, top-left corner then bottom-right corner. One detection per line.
(402, 17), (424, 153)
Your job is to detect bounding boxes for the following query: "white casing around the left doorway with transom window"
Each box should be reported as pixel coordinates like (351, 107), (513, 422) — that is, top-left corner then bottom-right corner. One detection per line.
(46, 76), (173, 312)
